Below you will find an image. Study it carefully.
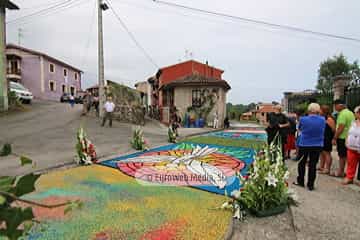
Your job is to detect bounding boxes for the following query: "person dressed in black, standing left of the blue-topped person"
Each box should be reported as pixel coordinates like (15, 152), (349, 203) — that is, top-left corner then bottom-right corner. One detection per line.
(265, 105), (290, 161)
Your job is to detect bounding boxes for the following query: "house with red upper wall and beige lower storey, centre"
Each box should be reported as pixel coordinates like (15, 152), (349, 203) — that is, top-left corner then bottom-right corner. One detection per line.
(148, 60), (231, 127)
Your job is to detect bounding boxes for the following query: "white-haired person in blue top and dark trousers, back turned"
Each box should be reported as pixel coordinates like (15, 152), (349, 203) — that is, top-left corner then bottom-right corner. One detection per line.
(294, 103), (326, 191)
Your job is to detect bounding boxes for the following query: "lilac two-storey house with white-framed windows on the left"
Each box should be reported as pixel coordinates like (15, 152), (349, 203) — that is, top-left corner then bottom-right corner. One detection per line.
(6, 44), (83, 101)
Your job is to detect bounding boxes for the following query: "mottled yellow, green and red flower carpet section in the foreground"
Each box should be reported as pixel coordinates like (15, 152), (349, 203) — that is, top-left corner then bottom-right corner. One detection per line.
(27, 165), (231, 240)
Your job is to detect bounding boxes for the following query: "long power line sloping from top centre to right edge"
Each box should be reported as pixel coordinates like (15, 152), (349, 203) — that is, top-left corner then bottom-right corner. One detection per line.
(152, 0), (360, 42)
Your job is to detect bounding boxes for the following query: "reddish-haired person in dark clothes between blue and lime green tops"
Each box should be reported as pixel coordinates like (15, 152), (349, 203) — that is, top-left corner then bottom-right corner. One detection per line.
(318, 105), (336, 174)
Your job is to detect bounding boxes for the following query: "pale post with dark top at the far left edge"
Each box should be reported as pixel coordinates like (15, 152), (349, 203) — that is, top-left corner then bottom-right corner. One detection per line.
(0, 0), (19, 112)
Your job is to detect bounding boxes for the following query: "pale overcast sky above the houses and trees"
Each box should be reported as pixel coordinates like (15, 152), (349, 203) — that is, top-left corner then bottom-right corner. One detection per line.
(7, 0), (360, 103)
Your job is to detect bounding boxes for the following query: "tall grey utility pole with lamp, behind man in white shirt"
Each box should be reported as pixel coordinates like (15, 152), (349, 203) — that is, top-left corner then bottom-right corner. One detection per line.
(98, 0), (109, 118)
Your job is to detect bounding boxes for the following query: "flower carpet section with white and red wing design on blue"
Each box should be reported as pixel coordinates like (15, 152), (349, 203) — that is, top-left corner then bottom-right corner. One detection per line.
(101, 143), (255, 194)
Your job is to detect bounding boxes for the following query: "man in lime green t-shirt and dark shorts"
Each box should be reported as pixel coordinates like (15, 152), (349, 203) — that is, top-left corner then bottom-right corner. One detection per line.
(330, 99), (355, 177)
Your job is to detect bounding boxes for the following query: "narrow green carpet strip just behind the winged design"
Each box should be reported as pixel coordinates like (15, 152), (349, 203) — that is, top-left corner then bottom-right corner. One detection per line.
(182, 136), (266, 150)
